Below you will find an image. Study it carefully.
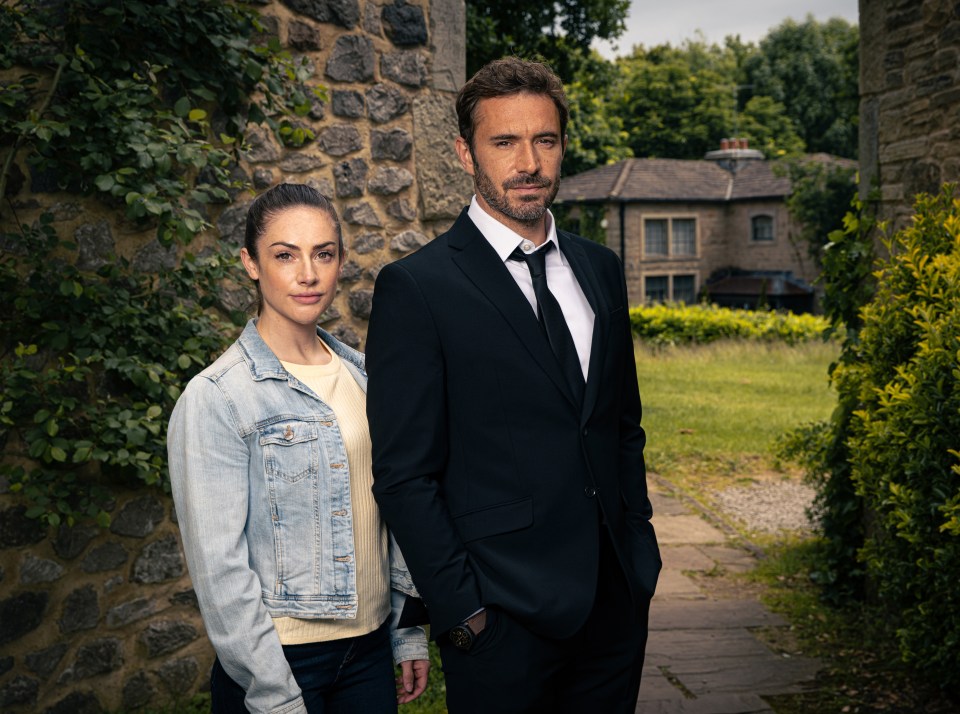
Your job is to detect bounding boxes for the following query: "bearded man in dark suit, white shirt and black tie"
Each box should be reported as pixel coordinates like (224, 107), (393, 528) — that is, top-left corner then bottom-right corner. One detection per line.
(367, 58), (660, 714)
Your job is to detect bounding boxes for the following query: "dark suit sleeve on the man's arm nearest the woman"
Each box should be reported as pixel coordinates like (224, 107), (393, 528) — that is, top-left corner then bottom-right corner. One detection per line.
(367, 263), (483, 636)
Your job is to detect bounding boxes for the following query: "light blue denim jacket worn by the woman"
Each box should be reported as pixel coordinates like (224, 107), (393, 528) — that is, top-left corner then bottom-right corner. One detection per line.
(167, 320), (427, 714)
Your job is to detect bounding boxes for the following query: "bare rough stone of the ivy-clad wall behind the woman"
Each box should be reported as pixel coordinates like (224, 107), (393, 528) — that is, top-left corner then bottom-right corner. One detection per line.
(0, 0), (472, 714)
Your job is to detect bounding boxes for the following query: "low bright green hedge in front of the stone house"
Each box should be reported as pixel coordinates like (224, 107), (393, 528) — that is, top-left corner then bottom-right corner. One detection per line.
(630, 304), (829, 344)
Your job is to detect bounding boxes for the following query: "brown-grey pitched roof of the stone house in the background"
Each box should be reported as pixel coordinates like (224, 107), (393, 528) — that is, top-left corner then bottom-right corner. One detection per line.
(557, 159), (790, 203)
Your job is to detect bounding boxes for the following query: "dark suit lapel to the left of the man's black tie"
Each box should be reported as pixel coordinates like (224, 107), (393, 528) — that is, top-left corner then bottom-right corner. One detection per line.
(449, 210), (573, 402)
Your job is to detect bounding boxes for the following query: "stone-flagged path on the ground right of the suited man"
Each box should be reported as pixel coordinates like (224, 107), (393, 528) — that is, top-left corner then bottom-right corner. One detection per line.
(636, 479), (819, 714)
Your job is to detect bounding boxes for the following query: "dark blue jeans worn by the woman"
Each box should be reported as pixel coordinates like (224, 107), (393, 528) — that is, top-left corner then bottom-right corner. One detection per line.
(210, 623), (397, 714)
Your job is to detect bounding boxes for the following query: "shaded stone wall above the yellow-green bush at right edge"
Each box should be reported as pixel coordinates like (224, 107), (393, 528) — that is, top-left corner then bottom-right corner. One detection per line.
(860, 0), (960, 227)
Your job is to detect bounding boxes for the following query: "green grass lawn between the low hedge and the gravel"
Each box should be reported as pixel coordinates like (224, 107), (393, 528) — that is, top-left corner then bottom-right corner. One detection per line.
(636, 341), (839, 490)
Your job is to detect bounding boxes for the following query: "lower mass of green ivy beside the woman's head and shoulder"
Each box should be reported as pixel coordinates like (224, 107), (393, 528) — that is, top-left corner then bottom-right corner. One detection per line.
(0, 215), (242, 526)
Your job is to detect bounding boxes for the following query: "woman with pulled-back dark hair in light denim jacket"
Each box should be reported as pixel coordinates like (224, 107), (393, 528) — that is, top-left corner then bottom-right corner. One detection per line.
(168, 184), (429, 714)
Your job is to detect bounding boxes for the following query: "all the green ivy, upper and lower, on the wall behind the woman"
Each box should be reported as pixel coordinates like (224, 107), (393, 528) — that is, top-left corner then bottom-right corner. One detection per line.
(0, 0), (323, 526)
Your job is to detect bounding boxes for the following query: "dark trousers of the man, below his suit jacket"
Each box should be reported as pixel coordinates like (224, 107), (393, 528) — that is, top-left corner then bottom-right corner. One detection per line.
(439, 533), (648, 714)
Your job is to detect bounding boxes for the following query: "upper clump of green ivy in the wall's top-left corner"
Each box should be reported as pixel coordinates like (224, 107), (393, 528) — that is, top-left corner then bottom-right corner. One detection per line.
(0, 0), (323, 243)
